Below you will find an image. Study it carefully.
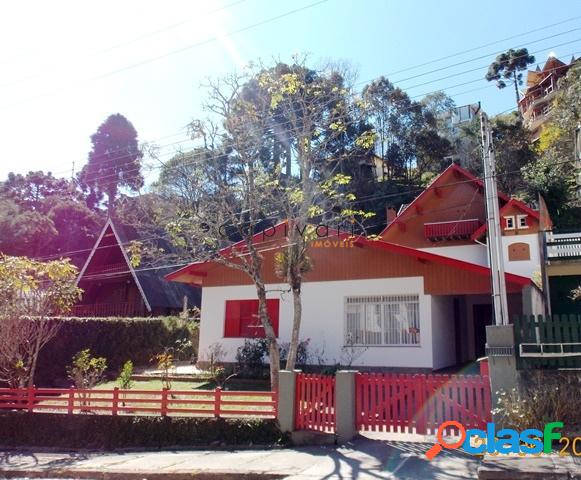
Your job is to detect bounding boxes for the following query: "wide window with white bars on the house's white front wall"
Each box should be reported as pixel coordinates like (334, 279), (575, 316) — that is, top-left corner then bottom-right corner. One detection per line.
(345, 295), (420, 345)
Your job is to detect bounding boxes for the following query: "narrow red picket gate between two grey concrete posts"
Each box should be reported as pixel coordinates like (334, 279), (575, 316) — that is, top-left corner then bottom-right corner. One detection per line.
(295, 373), (335, 432)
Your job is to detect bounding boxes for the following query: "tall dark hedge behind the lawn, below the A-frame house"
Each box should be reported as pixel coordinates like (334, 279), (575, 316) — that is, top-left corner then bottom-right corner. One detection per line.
(35, 317), (197, 386)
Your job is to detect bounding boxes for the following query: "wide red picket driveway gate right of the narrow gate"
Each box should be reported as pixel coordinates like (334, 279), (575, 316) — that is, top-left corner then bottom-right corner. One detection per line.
(355, 373), (491, 434)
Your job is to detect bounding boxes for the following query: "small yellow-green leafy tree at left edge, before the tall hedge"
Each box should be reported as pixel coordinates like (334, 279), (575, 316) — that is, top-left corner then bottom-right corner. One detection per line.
(0, 255), (81, 387)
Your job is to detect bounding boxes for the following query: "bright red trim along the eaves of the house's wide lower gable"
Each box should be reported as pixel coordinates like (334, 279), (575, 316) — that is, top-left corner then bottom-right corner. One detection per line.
(165, 221), (531, 286)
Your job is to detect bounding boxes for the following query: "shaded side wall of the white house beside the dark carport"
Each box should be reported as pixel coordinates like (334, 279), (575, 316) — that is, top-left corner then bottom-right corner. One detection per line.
(432, 295), (459, 369)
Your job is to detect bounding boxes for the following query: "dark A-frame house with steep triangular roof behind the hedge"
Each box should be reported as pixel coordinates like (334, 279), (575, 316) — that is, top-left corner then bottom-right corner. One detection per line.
(71, 219), (201, 317)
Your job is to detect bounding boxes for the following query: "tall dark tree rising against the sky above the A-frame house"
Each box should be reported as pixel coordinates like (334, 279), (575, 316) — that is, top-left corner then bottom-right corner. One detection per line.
(80, 113), (143, 214)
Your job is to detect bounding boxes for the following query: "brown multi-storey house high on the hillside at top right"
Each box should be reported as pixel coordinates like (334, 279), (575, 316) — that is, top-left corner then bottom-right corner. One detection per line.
(518, 56), (576, 141)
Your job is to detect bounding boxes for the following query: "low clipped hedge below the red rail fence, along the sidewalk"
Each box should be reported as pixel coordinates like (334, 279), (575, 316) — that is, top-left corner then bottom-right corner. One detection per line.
(0, 412), (285, 450)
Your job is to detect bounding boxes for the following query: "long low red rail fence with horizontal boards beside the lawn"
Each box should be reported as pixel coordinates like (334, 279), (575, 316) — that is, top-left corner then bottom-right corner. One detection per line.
(0, 387), (277, 418)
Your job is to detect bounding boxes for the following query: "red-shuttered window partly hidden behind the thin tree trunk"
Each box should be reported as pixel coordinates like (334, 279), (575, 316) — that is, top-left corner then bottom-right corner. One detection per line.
(224, 299), (279, 338)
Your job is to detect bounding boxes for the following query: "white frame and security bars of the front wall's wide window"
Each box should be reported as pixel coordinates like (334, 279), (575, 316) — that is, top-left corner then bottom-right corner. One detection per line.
(343, 293), (422, 348)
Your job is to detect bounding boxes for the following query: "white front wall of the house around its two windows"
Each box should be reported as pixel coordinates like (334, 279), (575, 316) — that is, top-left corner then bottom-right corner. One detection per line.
(200, 277), (433, 368)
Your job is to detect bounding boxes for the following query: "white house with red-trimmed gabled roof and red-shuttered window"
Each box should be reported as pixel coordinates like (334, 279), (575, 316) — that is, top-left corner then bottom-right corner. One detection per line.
(166, 165), (544, 370)
